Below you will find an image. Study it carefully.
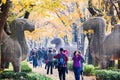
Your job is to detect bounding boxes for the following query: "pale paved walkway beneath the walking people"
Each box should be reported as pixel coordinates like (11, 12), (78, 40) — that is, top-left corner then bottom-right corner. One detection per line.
(28, 63), (95, 80)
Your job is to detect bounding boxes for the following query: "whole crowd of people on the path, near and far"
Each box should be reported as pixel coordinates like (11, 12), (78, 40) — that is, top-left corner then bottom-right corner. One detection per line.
(28, 48), (84, 80)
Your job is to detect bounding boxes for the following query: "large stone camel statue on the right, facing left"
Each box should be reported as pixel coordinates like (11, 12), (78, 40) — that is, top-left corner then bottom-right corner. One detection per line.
(83, 17), (120, 68)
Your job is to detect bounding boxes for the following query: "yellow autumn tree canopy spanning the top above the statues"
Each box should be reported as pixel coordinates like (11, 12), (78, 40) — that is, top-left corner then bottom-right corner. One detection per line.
(1, 0), (120, 39)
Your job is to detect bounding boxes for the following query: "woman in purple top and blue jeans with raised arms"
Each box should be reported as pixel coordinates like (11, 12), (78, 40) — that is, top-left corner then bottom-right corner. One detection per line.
(72, 51), (82, 80)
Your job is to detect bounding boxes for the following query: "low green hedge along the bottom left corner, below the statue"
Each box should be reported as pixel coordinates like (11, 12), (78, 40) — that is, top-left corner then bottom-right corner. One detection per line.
(0, 71), (52, 80)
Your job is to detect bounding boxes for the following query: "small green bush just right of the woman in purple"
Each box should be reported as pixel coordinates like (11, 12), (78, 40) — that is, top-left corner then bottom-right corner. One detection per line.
(83, 64), (95, 76)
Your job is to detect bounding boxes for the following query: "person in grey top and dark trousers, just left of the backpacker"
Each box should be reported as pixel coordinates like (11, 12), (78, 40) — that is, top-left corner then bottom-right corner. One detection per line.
(47, 50), (54, 74)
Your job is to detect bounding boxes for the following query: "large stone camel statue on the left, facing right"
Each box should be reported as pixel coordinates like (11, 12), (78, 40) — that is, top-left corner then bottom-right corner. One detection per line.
(1, 18), (35, 72)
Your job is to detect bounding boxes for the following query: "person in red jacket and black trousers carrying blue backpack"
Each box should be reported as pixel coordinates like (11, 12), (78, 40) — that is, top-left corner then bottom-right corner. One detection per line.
(54, 48), (68, 80)
